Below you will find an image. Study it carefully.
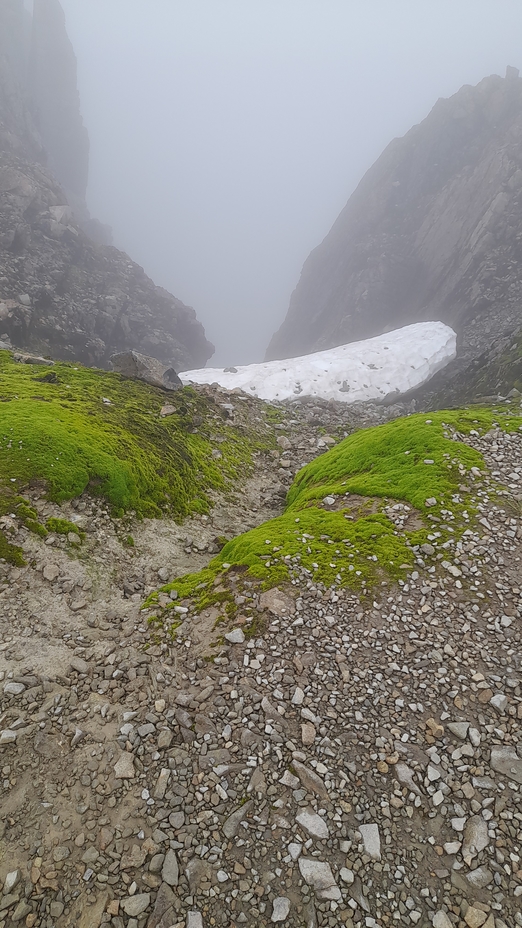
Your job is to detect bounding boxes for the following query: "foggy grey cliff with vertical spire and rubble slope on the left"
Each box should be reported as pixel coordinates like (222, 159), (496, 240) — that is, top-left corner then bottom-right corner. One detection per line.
(0, 0), (213, 370)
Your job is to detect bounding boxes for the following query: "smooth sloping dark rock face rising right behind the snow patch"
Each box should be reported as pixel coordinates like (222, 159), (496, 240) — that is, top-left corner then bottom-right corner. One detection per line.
(267, 68), (522, 363)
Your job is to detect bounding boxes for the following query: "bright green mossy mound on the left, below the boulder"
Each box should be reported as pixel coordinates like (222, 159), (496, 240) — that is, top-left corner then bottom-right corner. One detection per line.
(0, 351), (273, 559)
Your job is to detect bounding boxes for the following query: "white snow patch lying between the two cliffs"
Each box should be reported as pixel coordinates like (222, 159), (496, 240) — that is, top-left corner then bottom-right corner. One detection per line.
(179, 322), (457, 403)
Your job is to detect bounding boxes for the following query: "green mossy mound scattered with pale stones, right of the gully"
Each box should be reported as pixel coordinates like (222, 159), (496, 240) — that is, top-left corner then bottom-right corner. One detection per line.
(146, 408), (522, 628)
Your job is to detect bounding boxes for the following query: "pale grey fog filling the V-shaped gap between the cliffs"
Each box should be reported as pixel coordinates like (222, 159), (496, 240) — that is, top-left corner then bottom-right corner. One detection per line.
(62, 0), (522, 366)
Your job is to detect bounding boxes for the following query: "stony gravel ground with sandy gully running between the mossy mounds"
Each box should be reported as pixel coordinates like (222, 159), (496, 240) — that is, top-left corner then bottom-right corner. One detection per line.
(0, 386), (522, 928)
